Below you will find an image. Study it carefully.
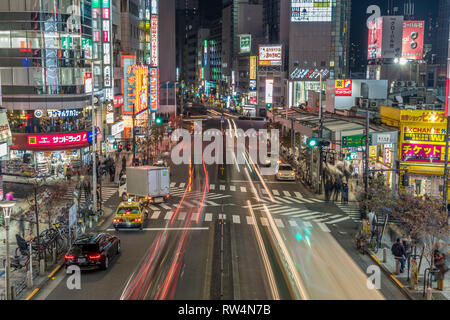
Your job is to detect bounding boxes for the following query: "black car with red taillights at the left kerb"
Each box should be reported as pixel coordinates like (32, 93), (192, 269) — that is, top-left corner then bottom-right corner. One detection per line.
(64, 233), (120, 270)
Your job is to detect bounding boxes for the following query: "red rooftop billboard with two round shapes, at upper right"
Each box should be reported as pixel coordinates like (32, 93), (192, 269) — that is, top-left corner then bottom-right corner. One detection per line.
(402, 21), (425, 60)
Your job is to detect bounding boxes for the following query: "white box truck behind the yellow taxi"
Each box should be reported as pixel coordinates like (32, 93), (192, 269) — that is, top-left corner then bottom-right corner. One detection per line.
(119, 166), (170, 203)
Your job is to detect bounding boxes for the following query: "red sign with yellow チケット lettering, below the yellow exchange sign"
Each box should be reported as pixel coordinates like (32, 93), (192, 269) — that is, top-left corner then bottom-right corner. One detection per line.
(402, 143), (445, 163)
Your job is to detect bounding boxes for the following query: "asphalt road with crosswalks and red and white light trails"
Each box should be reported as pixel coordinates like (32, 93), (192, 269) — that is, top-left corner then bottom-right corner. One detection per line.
(35, 110), (402, 300)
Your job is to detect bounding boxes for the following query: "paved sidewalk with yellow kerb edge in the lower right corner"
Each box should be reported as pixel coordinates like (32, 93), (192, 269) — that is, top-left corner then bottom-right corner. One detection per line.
(371, 234), (450, 300)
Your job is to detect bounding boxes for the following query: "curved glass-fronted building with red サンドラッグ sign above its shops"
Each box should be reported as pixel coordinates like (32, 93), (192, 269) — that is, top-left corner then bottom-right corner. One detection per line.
(0, 0), (97, 174)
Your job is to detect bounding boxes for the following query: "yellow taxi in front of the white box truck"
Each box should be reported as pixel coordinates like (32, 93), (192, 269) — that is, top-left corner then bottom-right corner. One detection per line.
(113, 199), (148, 231)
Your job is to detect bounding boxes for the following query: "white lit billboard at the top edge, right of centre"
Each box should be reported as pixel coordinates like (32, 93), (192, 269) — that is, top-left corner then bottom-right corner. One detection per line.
(291, 0), (333, 22)
